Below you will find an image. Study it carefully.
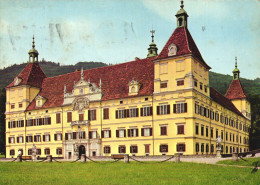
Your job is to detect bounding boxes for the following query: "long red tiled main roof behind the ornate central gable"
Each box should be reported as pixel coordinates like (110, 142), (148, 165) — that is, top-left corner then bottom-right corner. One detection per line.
(27, 57), (155, 110)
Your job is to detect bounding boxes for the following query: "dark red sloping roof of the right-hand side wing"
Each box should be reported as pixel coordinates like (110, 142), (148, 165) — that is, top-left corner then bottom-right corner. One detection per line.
(210, 87), (244, 117)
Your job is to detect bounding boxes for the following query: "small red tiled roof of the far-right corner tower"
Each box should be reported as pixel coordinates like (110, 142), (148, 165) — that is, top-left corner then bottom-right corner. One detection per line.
(225, 80), (247, 100)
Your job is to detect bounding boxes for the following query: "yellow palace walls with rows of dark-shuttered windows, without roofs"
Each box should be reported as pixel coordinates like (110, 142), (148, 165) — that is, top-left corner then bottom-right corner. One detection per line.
(6, 3), (251, 159)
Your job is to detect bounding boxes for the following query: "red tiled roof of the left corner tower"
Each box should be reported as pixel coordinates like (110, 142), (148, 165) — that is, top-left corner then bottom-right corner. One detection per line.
(7, 63), (46, 88)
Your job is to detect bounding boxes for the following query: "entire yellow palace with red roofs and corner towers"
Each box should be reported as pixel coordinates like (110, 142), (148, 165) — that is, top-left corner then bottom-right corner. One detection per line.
(6, 2), (251, 159)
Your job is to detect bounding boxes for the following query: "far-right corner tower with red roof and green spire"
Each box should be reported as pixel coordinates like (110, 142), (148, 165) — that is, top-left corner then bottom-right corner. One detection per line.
(225, 57), (251, 120)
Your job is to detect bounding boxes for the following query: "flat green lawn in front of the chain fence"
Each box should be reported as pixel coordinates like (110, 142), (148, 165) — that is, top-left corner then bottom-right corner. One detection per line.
(0, 162), (260, 185)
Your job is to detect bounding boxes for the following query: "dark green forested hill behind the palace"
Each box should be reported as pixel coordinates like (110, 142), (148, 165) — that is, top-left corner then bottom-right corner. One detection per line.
(0, 61), (260, 95)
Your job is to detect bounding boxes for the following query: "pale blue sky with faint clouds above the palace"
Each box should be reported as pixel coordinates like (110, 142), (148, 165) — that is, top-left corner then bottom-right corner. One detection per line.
(0, 0), (260, 79)
